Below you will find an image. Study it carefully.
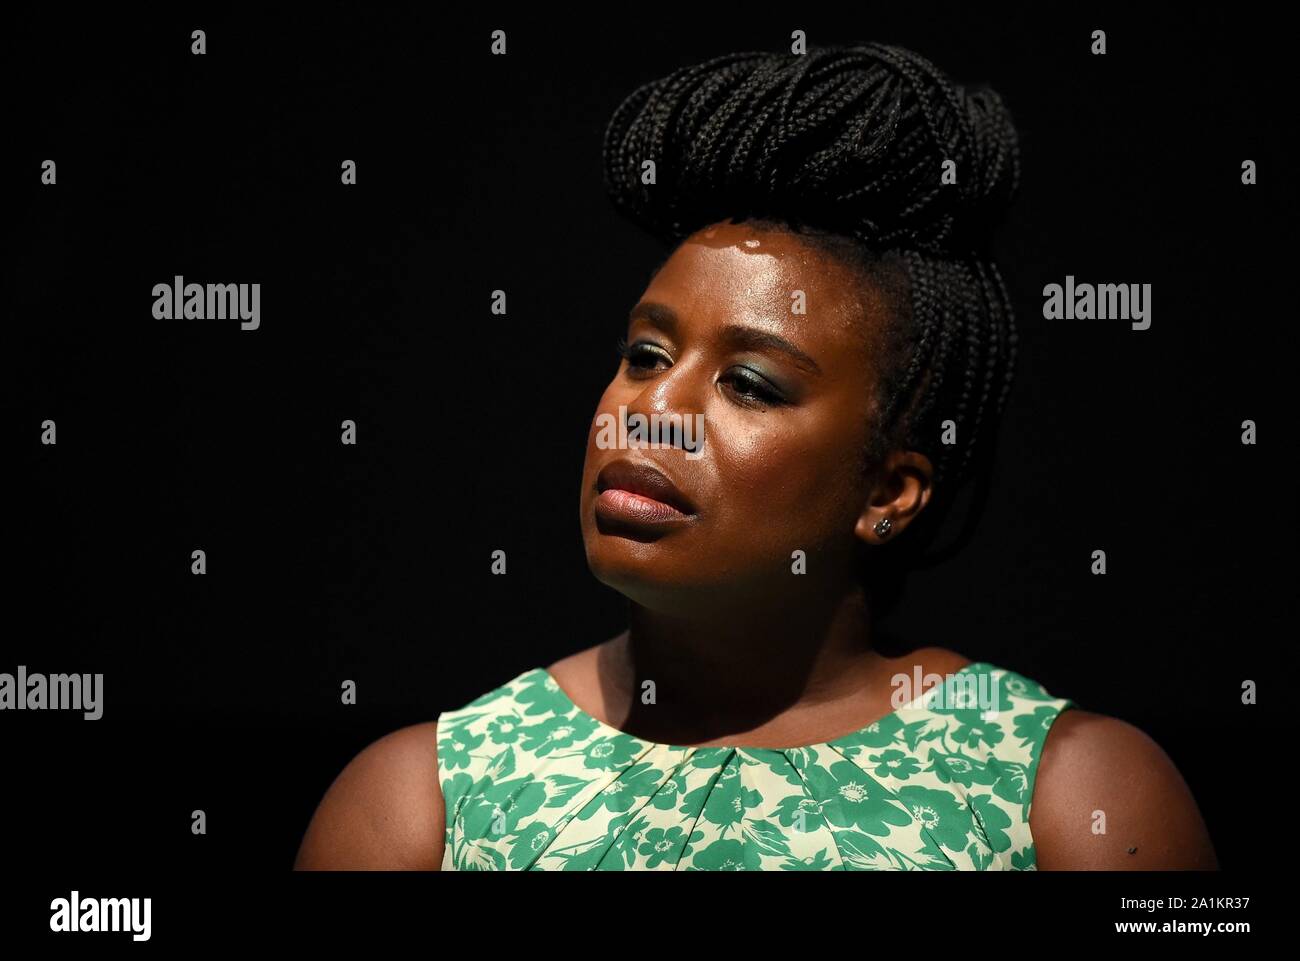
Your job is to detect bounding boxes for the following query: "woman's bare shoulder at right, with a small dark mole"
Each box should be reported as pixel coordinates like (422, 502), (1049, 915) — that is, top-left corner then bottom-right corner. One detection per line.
(1030, 707), (1218, 870)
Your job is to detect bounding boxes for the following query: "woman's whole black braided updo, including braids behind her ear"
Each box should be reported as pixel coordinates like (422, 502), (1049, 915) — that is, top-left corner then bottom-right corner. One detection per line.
(603, 43), (1019, 600)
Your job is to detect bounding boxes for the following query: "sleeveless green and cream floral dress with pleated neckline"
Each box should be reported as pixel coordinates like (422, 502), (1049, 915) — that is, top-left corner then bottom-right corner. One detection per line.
(438, 662), (1074, 871)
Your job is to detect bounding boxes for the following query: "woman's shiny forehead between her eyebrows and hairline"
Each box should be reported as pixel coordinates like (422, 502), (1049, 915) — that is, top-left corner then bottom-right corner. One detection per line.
(645, 222), (880, 348)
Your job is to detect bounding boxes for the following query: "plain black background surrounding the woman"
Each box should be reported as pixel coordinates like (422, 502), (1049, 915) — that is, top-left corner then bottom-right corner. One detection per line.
(0, 5), (1296, 893)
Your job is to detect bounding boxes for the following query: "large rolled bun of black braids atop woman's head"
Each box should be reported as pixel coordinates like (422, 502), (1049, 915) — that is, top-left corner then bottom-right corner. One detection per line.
(605, 43), (1019, 251)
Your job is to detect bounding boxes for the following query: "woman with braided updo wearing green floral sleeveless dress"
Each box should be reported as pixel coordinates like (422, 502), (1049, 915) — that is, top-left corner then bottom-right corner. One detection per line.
(298, 44), (1217, 870)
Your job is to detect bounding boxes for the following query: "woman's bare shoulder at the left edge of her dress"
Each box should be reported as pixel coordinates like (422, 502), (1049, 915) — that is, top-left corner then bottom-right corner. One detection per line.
(294, 720), (445, 870)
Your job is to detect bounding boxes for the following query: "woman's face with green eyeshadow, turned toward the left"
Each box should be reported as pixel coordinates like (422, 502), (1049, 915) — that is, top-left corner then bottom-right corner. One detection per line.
(581, 222), (904, 614)
